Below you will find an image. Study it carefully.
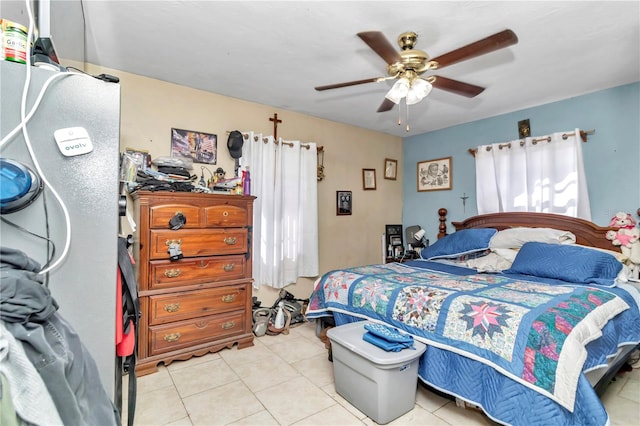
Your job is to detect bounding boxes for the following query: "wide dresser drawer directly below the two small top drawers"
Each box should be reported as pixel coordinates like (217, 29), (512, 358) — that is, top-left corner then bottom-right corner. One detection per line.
(149, 228), (248, 260)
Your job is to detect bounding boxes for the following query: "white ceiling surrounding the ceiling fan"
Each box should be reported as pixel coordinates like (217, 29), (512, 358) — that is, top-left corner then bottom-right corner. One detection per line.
(28, 0), (640, 136)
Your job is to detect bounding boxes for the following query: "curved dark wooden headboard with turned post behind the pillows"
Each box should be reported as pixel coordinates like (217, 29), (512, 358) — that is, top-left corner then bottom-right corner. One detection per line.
(438, 209), (620, 251)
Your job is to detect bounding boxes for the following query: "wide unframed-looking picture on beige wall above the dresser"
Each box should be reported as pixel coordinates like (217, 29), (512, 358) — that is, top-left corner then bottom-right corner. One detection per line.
(171, 128), (218, 164)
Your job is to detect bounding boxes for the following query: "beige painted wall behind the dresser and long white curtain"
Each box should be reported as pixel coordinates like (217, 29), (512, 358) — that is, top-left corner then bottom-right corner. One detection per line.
(79, 64), (402, 306)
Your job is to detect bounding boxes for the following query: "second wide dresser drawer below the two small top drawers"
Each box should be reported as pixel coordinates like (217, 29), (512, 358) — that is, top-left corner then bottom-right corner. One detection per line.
(149, 254), (248, 290)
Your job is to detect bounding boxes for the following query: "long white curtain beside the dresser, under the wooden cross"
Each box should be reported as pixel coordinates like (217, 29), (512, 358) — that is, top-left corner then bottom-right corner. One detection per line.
(241, 132), (319, 288)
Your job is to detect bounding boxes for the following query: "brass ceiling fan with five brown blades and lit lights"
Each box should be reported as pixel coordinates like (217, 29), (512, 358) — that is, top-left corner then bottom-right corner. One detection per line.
(315, 30), (518, 112)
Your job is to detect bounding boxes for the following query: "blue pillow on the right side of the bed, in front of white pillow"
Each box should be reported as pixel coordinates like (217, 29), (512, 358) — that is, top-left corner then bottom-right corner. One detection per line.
(502, 242), (622, 287)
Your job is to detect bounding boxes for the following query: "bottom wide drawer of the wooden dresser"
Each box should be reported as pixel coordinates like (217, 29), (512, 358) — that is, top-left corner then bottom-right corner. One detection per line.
(149, 311), (246, 355)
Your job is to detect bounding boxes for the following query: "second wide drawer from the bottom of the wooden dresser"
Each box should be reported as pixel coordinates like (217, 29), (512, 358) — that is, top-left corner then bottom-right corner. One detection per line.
(149, 284), (248, 325)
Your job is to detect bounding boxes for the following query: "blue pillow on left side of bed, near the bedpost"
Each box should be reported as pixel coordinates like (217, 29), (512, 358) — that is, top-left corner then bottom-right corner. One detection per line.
(421, 228), (498, 260)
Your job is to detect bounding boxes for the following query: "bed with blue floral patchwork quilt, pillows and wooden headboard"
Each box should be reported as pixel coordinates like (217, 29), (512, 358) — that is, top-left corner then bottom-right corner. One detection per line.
(306, 209), (640, 425)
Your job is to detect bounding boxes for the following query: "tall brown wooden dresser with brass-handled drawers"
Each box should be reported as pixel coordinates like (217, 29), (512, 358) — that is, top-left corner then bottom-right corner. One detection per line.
(133, 191), (255, 376)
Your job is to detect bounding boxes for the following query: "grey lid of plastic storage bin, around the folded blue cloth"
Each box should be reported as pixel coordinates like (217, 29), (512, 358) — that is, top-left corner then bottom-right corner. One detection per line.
(327, 321), (427, 365)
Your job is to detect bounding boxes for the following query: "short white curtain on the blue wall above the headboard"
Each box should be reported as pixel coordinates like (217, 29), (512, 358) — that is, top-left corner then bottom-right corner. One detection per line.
(476, 129), (591, 220)
